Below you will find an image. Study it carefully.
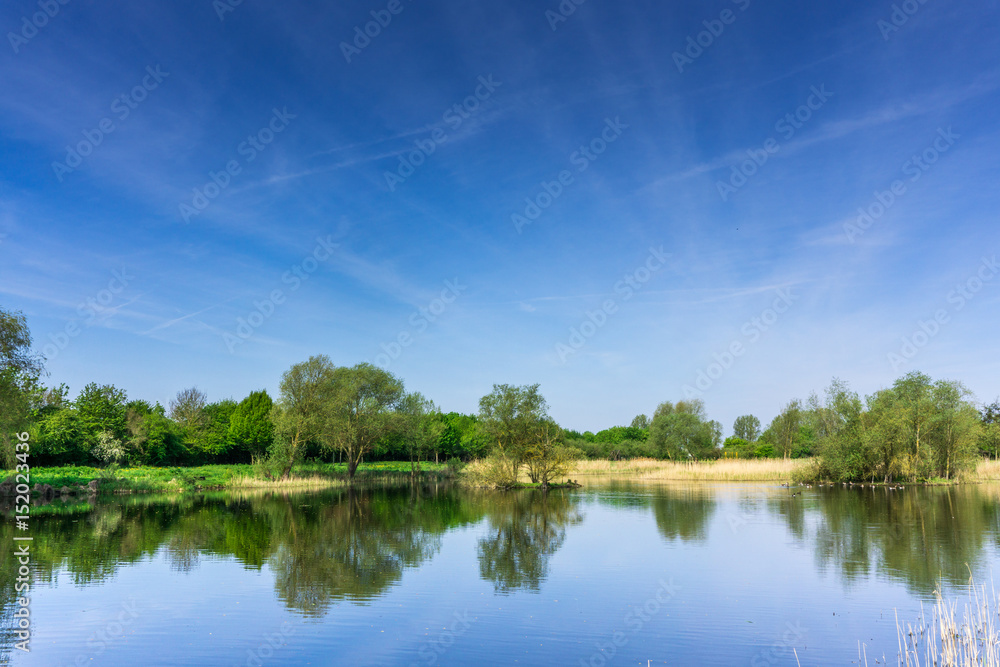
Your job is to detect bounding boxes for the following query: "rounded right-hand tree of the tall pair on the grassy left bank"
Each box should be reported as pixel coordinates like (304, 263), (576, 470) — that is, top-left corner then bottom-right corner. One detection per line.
(325, 363), (405, 479)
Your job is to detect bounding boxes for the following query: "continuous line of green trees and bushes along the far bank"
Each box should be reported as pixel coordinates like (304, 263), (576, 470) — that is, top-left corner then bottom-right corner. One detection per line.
(0, 309), (1000, 485)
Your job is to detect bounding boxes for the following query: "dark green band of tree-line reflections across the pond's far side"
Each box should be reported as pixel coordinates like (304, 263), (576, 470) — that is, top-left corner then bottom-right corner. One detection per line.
(0, 483), (1000, 662)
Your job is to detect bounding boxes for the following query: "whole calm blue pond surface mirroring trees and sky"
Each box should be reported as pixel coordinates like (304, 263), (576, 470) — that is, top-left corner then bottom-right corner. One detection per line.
(0, 484), (1000, 667)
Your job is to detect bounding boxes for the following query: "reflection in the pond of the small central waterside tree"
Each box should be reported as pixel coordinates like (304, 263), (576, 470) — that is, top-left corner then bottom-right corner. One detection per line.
(477, 491), (582, 594)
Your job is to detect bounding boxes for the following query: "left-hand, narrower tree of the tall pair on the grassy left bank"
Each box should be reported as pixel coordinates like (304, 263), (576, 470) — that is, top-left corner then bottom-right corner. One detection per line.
(270, 354), (336, 479)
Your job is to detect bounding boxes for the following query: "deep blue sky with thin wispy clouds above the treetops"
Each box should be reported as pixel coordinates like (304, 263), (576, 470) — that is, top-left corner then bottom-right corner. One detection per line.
(0, 0), (1000, 433)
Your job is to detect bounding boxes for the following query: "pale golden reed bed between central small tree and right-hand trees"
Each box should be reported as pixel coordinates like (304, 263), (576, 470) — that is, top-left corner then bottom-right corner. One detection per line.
(567, 459), (808, 482)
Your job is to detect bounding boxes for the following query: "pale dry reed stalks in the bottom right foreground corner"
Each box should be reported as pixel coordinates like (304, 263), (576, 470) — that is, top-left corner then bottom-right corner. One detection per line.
(880, 584), (1000, 667)
